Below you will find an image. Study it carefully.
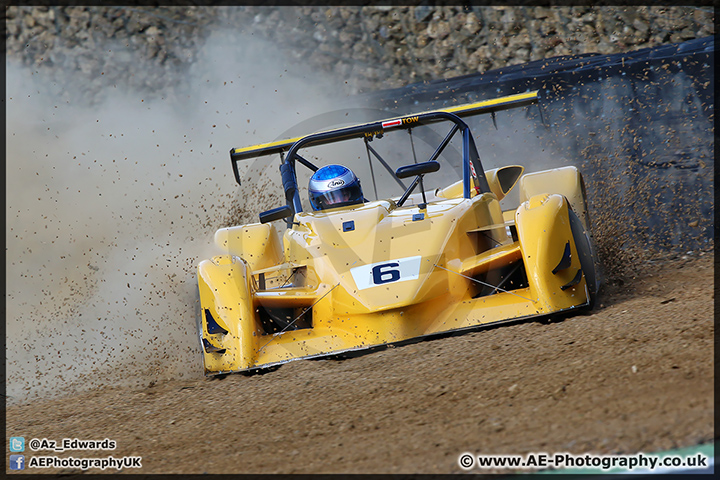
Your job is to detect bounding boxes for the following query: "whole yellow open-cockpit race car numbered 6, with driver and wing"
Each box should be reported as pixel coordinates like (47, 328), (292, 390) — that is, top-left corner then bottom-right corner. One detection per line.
(198, 92), (597, 374)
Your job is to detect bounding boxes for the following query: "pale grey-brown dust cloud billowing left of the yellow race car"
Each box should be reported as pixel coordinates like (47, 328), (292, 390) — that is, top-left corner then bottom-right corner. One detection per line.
(6, 32), (346, 404)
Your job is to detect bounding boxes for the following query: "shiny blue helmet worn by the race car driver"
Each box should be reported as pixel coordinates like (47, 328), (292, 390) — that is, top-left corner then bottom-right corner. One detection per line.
(308, 165), (365, 211)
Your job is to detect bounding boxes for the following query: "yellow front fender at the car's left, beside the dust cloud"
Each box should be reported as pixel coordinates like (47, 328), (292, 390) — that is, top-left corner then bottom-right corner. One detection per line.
(198, 255), (261, 373)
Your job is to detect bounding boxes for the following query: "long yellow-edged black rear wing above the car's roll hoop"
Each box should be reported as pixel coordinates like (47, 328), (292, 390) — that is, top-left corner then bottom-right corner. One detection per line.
(230, 90), (538, 165)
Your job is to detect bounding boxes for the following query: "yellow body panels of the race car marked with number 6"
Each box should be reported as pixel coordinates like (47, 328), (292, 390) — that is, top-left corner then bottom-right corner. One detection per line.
(198, 167), (590, 374)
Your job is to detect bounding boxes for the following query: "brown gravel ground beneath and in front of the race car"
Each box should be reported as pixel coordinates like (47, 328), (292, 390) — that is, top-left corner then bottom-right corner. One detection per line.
(6, 254), (714, 473)
